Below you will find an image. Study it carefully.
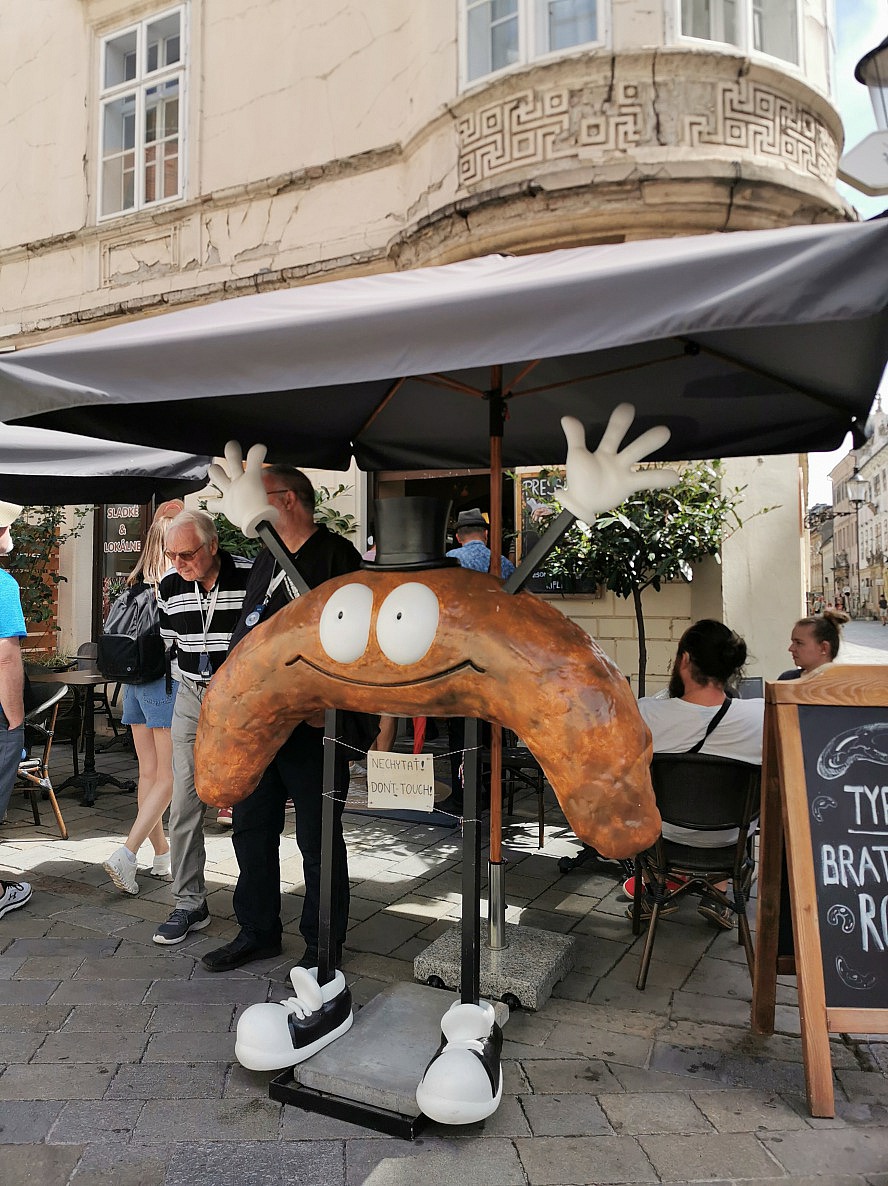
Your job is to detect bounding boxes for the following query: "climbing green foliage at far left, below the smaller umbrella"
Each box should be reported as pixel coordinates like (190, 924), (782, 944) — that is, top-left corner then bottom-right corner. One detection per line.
(4, 506), (89, 630)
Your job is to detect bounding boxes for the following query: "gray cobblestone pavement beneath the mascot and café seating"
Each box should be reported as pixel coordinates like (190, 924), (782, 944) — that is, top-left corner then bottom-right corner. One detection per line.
(0, 649), (888, 1186)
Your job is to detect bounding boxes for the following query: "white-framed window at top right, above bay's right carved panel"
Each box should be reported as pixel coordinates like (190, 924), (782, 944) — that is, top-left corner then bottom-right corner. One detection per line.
(681, 0), (799, 65)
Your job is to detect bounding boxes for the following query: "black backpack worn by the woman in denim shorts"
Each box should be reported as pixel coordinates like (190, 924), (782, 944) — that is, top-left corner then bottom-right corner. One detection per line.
(96, 581), (166, 683)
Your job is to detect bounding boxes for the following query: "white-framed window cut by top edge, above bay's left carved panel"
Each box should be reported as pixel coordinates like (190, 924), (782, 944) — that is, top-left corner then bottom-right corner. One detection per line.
(464, 0), (601, 83)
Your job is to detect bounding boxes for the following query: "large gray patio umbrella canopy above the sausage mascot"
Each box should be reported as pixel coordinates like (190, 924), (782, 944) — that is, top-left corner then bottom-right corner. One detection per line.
(0, 221), (888, 470)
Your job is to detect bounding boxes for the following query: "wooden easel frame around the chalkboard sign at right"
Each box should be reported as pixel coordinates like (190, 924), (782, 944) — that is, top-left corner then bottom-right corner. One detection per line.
(752, 664), (888, 1117)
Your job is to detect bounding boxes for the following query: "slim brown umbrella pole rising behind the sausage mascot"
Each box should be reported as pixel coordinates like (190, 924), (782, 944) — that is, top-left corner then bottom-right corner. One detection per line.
(487, 389), (506, 951)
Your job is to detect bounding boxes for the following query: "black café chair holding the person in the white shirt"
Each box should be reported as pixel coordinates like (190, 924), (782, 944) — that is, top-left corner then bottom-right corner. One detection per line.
(632, 753), (761, 989)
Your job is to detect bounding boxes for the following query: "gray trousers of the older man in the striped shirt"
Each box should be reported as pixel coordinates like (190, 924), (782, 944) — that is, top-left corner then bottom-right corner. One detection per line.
(170, 681), (206, 910)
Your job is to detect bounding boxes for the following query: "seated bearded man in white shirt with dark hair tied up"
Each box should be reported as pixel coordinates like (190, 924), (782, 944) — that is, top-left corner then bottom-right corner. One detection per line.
(630, 618), (765, 930)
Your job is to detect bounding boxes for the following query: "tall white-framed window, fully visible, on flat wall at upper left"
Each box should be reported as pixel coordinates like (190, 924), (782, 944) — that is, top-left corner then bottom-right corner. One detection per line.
(98, 8), (185, 217)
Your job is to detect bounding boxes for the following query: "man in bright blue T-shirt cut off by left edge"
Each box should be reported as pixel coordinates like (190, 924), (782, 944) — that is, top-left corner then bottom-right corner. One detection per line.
(0, 503), (32, 918)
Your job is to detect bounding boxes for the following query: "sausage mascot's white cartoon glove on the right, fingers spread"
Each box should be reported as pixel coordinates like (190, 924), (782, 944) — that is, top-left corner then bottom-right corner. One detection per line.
(557, 403), (678, 523)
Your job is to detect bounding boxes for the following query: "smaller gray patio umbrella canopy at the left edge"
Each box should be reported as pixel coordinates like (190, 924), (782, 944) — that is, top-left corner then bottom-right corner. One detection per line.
(0, 425), (211, 505)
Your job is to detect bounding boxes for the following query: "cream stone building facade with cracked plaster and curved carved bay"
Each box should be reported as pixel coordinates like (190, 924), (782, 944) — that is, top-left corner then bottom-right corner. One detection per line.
(0, 0), (855, 674)
